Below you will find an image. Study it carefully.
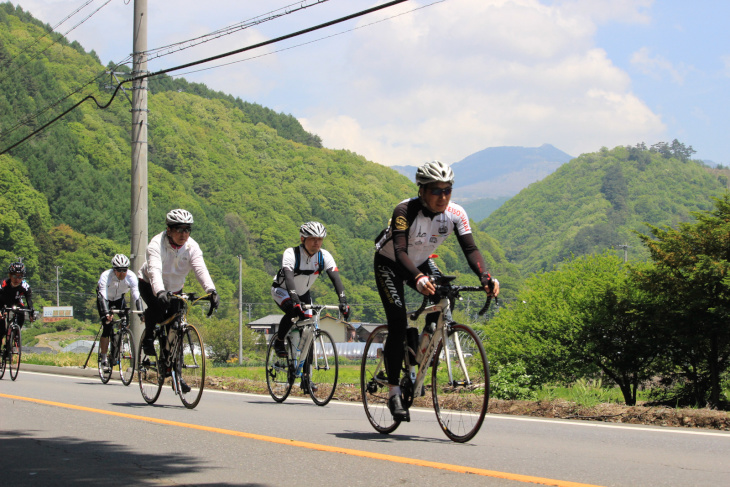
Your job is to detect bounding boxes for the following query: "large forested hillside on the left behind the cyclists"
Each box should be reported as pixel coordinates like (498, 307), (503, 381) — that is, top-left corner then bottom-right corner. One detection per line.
(0, 3), (517, 320)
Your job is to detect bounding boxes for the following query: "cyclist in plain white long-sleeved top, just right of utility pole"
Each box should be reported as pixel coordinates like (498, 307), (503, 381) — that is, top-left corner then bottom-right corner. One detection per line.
(137, 208), (220, 393)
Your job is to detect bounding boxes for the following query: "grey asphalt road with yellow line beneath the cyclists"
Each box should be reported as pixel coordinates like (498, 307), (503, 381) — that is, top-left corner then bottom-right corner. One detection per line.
(0, 364), (730, 487)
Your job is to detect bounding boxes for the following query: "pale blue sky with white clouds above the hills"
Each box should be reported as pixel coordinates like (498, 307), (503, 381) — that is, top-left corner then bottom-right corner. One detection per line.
(12, 0), (730, 166)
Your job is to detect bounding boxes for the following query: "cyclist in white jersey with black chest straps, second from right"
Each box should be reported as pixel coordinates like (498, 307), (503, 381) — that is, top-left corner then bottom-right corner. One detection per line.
(271, 222), (350, 357)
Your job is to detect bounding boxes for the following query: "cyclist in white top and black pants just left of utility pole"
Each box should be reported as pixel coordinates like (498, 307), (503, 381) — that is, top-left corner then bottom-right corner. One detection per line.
(96, 254), (143, 367)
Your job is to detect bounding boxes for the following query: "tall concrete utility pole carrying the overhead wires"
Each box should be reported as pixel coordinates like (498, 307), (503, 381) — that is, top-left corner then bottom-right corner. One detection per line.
(130, 0), (149, 350)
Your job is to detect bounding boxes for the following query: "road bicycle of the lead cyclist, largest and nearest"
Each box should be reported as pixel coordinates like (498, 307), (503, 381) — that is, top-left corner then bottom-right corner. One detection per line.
(360, 276), (491, 443)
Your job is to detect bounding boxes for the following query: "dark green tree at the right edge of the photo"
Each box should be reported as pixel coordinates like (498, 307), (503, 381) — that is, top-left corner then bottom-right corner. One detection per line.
(637, 194), (730, 407)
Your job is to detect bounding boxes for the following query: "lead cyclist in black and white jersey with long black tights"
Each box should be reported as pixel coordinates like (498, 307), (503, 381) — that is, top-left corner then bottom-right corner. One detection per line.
(374, 161), (499, 420)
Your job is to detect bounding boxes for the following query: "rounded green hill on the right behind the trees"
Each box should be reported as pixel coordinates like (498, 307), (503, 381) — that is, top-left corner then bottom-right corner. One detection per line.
(479, 144), (730, 273)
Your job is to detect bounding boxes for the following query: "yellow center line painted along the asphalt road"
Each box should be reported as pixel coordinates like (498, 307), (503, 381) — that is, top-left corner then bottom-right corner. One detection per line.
(0, 394), (599, 487)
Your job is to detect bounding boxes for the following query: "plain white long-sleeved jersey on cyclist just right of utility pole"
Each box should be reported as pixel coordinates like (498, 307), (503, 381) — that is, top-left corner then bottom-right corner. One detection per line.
(137, 230), (215, 296)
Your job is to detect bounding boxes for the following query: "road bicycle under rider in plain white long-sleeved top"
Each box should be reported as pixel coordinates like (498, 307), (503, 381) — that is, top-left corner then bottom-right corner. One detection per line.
(137, 293), (213, 409)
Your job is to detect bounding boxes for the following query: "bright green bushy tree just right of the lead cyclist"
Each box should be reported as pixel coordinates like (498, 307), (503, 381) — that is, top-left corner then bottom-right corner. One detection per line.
(486, 252), (661, 405)
